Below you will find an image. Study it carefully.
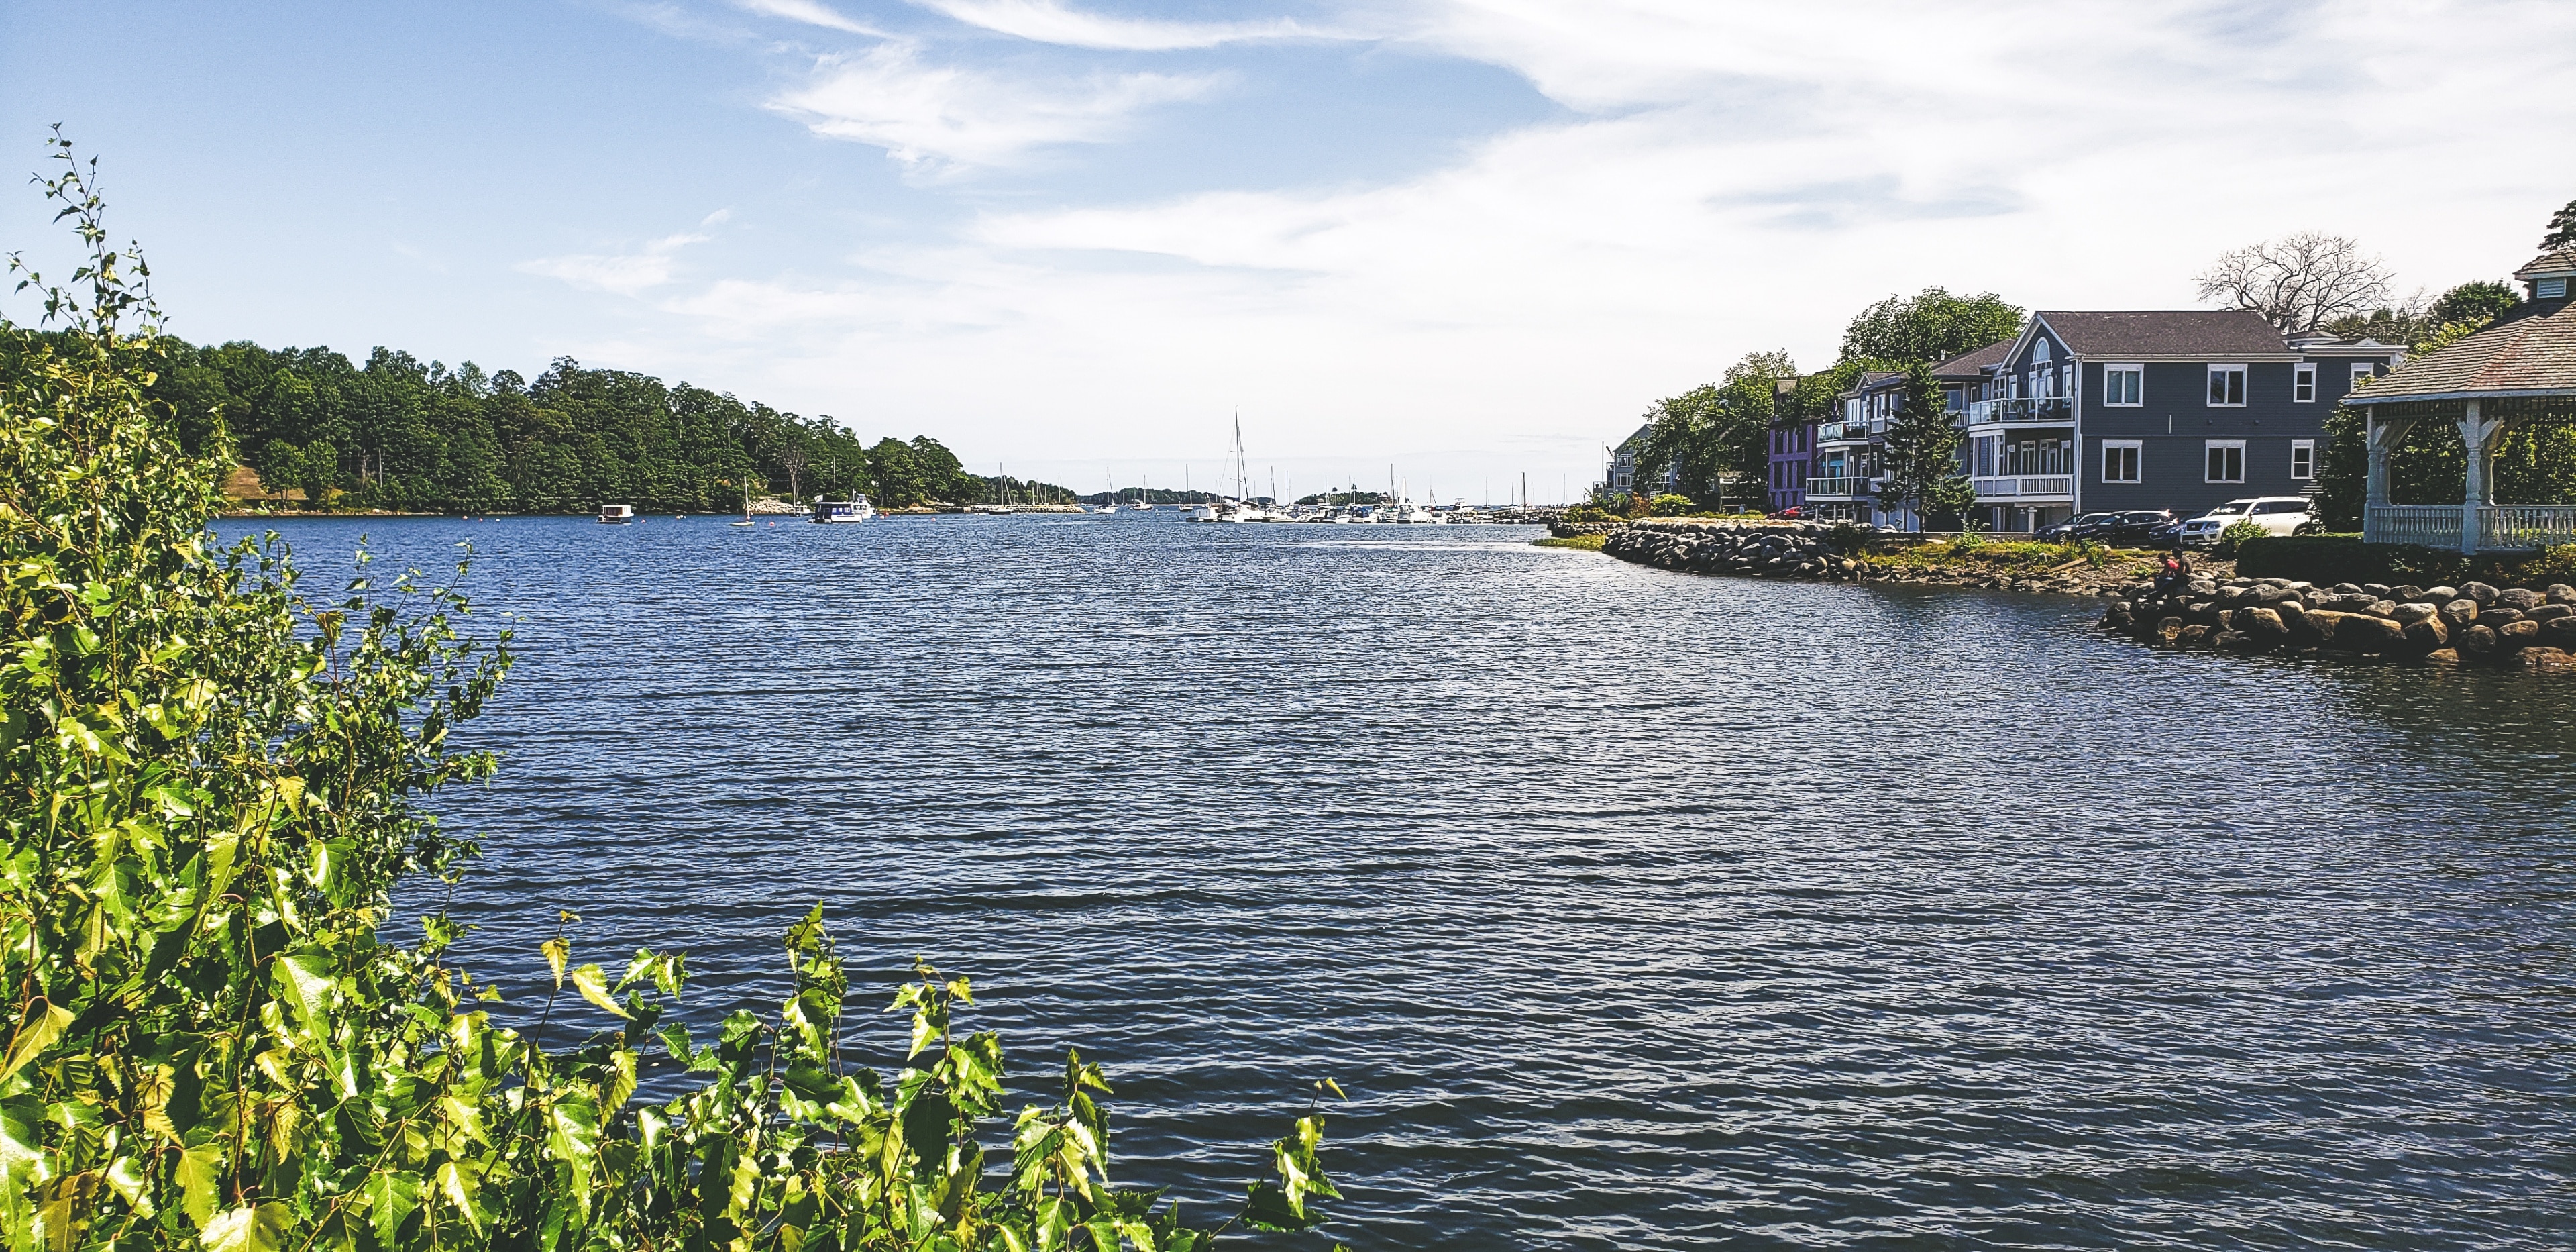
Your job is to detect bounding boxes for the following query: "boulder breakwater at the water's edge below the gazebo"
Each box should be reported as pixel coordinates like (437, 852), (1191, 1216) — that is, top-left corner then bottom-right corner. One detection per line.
(2102, 577), (2576, 675)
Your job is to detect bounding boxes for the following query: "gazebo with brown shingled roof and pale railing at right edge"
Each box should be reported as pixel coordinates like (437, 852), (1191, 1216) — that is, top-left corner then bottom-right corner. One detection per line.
(2344, 248), (2576, 554)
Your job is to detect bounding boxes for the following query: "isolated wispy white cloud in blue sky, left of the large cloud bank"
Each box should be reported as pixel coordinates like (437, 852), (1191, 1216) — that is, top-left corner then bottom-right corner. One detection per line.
(770, 44), (1216, 170)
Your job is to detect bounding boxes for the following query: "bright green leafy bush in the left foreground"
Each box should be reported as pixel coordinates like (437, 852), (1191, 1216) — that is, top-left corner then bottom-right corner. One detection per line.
(0, 139), (1340, 1252)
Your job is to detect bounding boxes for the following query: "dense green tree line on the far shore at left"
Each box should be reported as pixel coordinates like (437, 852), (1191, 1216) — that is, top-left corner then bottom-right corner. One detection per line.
(133, 340), (1069, 513)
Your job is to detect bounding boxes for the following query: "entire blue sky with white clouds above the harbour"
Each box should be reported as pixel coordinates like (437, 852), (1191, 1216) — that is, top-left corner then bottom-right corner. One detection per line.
(0, 0), (2576, 503)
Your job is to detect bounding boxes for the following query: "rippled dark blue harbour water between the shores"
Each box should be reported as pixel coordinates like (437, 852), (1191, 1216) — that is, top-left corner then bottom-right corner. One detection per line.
(237, 515), (2576, 1249)
